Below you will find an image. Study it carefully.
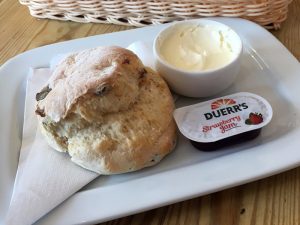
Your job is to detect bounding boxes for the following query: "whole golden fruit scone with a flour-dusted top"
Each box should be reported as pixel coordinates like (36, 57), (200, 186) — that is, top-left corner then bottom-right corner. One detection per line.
(36, 47), (176, 174)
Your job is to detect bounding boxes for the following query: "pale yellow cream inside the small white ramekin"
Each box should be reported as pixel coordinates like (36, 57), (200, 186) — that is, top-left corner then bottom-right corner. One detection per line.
(160, 24), (236, 72)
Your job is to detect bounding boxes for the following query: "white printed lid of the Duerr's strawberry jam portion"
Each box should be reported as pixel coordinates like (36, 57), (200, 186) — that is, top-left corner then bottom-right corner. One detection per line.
(174, 92), (273, 143)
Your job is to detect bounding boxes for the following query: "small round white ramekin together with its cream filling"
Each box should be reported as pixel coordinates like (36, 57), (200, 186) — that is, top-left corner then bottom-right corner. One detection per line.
(153, 19), (242, 97)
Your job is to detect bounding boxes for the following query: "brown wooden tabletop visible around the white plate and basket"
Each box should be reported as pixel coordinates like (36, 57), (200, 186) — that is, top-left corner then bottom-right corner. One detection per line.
(0, 0), (300, 225)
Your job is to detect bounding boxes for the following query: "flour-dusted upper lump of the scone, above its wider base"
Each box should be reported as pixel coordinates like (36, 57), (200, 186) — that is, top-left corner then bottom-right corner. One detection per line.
(38, 46), (144, 122)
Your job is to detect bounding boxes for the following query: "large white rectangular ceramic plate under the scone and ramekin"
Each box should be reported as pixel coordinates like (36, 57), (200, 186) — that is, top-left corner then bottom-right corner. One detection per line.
(0, 18), (300, 224)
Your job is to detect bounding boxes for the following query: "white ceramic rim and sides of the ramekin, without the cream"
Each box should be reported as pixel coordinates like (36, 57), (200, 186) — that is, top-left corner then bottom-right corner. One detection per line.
(153, 19), (243, 97)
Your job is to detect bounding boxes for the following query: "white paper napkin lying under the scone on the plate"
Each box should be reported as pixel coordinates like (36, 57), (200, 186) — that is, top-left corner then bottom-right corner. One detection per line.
(6, 42), (154, 225)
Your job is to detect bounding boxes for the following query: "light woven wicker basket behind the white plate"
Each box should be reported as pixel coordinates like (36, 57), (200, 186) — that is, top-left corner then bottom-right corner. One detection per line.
(20, 0), (292, 29)
